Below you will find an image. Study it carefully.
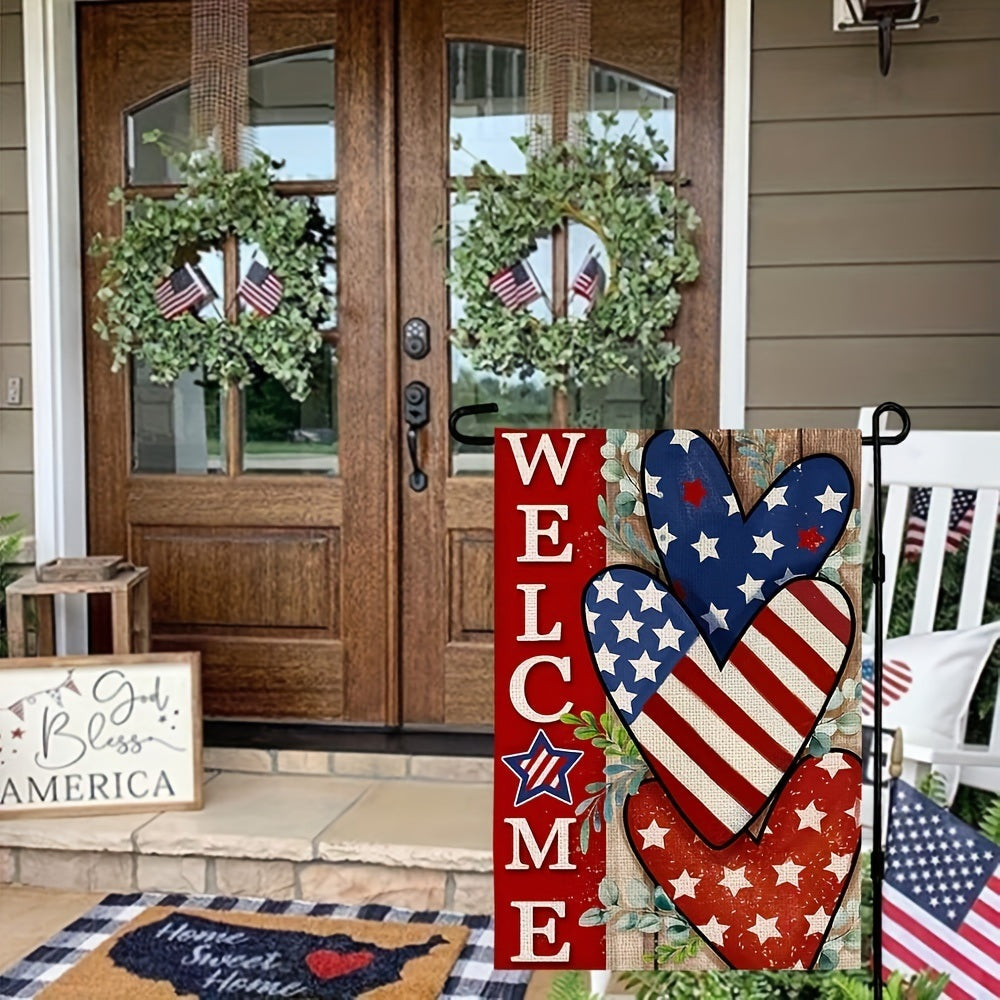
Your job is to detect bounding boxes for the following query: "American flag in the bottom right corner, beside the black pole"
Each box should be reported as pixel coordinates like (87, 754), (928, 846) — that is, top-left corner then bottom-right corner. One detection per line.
(882, 780), (1000, 1000)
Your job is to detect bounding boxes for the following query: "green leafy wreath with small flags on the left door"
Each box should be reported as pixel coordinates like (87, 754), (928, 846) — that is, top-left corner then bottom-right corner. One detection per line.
(90, 133), (334, 400)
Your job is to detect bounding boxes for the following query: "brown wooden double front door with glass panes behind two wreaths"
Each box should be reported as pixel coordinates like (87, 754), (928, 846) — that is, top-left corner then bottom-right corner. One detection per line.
(78, 0), (722, 727)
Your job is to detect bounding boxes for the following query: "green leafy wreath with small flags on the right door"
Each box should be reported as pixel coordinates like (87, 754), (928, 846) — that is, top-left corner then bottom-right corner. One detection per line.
(448, 111), (700, 390)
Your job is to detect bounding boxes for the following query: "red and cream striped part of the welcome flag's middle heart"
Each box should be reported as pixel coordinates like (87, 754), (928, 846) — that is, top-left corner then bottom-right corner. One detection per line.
(631, 580), (852, 847)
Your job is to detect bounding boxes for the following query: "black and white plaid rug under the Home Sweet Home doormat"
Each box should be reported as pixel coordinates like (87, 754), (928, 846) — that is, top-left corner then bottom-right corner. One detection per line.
(0, 892), (530, 1000)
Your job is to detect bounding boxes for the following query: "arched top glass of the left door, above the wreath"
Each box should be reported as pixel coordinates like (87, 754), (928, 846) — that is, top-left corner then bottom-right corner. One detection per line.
(126, 48), (336, 185)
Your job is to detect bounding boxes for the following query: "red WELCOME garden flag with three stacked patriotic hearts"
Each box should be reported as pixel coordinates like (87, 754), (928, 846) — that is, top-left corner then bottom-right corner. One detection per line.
(494, 429), (862, 969)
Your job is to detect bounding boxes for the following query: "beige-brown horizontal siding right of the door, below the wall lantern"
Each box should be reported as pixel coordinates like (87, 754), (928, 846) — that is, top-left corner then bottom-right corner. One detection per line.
(747, 0), (1000, 428)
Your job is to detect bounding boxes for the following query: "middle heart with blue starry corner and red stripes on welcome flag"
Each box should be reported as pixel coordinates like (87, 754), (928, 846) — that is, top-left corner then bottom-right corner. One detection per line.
(584, 566), (854, 847)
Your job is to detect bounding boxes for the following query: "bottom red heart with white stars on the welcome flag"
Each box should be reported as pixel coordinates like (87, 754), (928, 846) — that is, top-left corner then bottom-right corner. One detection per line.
(625, 750), (861, 969)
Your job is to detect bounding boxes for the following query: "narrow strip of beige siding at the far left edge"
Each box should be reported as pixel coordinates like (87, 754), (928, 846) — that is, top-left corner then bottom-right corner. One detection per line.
(0, 0), (33, 533)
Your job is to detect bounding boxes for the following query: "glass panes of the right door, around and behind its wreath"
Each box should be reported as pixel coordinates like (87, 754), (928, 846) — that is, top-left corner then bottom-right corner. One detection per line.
(448, 48), (677, 475)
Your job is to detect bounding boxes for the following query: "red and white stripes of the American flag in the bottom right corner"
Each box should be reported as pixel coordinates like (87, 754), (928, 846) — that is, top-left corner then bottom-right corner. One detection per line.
(882, 872), (1000, 1000)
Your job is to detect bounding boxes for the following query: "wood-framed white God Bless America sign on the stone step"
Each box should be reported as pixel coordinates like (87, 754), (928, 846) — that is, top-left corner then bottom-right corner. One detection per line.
(0, 653), (202, 818)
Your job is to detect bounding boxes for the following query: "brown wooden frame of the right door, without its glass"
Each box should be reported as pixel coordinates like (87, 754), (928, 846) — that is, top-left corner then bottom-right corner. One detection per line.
(397, 0), (724, 726)
